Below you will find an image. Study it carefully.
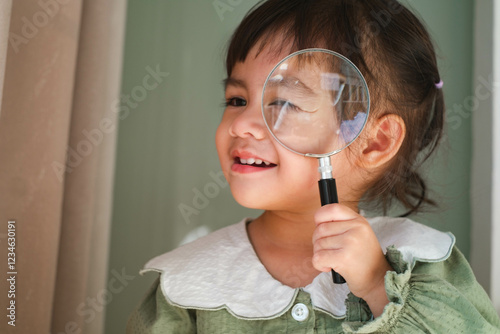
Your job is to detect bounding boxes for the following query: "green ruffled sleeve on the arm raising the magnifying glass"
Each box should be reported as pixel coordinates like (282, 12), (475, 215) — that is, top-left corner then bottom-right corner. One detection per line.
(343, 247), (500, 334)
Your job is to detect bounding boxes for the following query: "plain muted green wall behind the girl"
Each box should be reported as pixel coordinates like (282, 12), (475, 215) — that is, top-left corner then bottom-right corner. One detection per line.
(105, 0), (473, 334)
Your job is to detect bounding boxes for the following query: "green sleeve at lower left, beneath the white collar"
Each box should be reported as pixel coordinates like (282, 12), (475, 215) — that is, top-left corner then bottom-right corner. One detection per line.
(126, 279), (196, 334)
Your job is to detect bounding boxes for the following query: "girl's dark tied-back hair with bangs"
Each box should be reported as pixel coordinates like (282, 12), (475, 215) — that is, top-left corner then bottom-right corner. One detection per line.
(226, 0), (444, 215)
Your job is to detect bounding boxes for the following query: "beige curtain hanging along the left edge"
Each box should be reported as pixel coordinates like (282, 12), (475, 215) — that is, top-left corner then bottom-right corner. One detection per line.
(0, 0), (126, 334)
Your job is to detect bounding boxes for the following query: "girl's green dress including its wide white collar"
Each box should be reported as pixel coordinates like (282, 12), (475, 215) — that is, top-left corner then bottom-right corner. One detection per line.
(127, 217), (500, 334)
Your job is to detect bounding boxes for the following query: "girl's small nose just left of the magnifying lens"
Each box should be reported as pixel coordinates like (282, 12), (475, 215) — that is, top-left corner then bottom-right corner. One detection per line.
(229, 103), (267, 140)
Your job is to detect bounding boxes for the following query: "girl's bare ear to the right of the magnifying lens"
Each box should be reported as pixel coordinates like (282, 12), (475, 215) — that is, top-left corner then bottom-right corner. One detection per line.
(361, 114), (406, 168)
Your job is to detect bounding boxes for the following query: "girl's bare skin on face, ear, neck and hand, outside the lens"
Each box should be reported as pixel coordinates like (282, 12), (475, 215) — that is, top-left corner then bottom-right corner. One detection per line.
(216, 43), (405, 317)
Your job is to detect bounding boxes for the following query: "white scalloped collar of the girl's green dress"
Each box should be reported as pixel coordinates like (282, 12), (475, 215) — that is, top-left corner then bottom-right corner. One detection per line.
(141, 217), (455, 319)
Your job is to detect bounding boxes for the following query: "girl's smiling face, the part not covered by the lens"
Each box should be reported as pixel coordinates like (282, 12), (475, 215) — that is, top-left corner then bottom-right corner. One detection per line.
(216, 43), (362, 213)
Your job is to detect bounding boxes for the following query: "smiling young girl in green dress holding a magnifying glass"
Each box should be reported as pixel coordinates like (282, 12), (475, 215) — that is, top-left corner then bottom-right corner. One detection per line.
(127, 0), (500, 333)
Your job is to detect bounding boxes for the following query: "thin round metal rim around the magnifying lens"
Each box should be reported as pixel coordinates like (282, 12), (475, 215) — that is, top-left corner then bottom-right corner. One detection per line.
(261, 48), (370, 158)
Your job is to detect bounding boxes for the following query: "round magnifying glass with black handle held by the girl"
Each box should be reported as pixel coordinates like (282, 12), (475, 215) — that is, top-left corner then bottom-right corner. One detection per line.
(262, 48), (370, 284)
